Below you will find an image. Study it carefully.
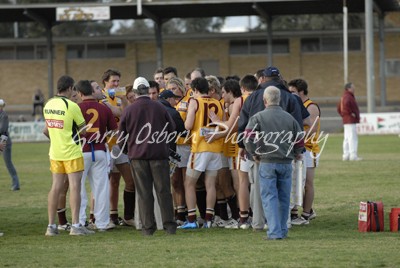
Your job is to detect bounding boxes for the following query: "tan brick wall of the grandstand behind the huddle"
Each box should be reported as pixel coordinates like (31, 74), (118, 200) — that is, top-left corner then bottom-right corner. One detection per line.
(0, 32), (400, 105)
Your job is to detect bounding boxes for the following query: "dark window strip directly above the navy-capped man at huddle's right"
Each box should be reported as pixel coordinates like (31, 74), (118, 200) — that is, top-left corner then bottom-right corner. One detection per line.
(229, 39), (289, 55)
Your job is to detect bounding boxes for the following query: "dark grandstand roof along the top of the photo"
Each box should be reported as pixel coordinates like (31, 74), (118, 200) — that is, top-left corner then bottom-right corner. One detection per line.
(0, 0), (400, 24)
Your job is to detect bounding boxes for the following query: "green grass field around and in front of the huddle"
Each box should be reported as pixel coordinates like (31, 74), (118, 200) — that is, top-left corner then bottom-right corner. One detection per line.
(0, 135), (400, 267)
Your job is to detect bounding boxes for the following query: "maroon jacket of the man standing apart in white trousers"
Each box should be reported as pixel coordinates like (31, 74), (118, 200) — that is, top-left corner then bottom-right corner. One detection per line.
(337, 90), (360, 124)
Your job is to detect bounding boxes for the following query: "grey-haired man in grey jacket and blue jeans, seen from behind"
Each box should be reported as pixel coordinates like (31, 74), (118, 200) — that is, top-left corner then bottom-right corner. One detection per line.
(244, 86), (304, 240)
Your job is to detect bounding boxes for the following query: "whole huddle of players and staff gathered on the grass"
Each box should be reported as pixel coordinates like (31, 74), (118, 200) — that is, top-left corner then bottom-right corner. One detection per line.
(43, 67), (320, 240)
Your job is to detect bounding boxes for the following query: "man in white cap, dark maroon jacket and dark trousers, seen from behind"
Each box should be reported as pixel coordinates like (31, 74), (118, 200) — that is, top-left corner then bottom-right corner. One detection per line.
(119, 77), (177, 235)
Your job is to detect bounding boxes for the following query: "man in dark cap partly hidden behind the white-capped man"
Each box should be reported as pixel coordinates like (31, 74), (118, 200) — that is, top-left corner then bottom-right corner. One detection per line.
(158, 90), (186, 152)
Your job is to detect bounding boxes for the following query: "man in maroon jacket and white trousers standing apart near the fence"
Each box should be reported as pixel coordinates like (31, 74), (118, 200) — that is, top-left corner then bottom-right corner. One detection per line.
(337, 83), (362, 161)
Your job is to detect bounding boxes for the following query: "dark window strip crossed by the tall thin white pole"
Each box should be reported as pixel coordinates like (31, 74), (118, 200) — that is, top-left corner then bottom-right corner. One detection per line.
(301, 36), (361, 53)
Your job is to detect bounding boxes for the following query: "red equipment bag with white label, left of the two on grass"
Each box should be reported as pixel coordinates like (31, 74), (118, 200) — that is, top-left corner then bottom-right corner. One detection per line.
(358, 201), (384, 232)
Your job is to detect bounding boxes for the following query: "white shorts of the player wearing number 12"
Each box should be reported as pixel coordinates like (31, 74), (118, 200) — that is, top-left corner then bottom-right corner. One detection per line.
(187, 152), (222, 172)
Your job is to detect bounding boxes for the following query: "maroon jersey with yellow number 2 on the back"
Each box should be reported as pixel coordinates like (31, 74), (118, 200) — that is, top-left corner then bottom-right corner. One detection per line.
(79, 100), (118, 152)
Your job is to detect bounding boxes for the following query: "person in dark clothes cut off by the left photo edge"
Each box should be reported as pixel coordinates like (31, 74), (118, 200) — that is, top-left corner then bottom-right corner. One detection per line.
(0, 99), (20, 191)
